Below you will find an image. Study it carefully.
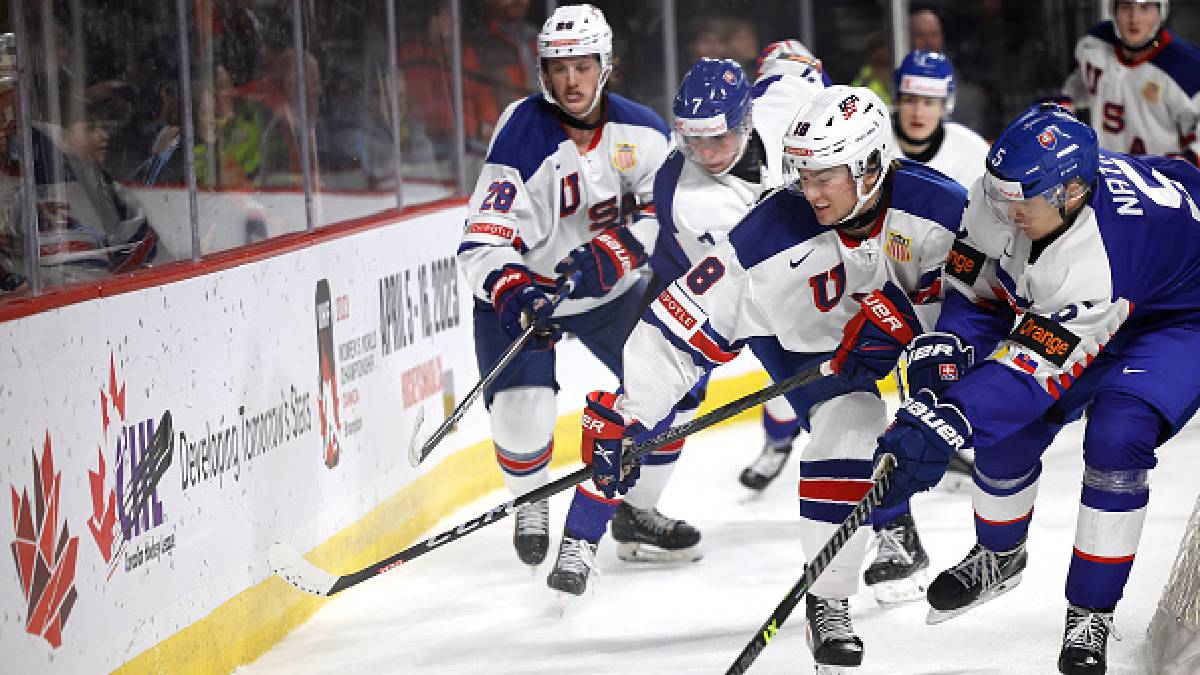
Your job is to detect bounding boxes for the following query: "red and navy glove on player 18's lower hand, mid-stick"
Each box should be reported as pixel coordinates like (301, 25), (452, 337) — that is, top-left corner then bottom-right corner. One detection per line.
(580, 392), (646, 500)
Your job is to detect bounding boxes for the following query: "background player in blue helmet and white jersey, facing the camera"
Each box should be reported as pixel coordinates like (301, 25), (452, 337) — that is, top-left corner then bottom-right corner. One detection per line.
(892, 52), (988, 187)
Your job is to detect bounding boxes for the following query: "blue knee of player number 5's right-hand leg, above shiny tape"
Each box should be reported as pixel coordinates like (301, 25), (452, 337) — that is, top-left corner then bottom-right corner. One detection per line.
(1084, 392), (1164, 471)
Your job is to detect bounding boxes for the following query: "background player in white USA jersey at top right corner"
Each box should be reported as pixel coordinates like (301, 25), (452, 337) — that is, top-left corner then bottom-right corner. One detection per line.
(1063, 0), (1200, 165)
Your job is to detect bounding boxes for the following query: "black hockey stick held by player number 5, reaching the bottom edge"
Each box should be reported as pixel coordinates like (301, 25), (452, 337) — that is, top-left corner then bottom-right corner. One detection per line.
(725, 454), (896, 675)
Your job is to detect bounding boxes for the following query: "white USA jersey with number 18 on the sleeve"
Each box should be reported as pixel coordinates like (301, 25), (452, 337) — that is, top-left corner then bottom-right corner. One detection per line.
(624, 161), (966, 420)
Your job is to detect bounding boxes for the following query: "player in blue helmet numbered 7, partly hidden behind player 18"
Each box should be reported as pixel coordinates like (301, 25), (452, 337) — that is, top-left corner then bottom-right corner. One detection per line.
(547, 53), (823, 595)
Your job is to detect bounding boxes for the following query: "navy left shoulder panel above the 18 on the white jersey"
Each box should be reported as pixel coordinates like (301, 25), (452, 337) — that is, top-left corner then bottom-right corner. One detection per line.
(730, 187), (829, 269)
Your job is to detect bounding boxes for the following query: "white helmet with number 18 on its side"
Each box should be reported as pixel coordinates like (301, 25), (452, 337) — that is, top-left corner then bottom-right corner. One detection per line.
(784, 84), (895, 223)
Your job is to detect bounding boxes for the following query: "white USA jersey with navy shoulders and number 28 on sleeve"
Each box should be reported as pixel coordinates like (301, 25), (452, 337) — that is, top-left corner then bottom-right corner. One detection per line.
(458, 94), (668, 315)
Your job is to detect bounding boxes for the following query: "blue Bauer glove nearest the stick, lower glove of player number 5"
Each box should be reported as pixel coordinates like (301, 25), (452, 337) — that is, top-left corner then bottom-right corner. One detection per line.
(875, 389), (972, 507)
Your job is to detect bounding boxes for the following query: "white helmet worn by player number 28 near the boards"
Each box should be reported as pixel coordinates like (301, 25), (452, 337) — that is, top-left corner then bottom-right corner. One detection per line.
(538, 5), (612, 117)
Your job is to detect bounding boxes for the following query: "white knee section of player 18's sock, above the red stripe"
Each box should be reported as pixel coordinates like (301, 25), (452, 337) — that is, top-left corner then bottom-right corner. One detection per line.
(803, 392), (888, 461)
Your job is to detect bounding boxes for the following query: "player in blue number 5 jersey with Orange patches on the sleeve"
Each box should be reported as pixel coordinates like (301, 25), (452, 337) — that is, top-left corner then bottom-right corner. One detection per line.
(878, 104), (1200, 674)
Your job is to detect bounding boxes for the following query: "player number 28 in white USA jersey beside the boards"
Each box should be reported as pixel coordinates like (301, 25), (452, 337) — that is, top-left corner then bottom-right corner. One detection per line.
(458, 5), (670, 565)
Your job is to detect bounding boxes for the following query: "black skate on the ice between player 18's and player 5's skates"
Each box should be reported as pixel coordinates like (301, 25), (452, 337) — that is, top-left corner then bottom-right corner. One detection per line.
(863, 513), (929, 607)
